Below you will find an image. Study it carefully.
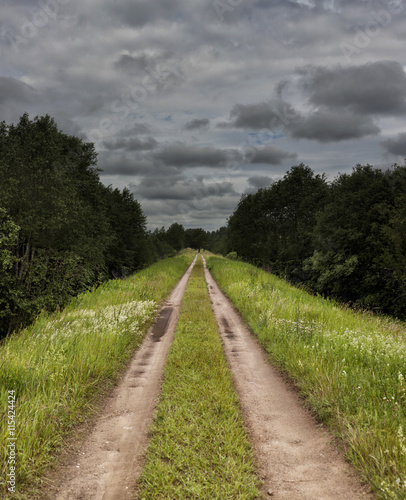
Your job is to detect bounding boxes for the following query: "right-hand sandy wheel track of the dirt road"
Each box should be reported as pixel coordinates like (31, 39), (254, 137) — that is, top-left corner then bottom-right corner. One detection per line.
(205, 258), (373, 500)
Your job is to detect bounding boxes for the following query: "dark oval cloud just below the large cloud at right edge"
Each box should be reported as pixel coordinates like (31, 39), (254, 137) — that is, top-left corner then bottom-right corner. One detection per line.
(289, 109), (380, 143)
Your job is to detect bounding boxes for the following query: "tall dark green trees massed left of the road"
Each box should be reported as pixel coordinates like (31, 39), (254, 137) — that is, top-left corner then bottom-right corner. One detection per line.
(0, 114), (149, 337)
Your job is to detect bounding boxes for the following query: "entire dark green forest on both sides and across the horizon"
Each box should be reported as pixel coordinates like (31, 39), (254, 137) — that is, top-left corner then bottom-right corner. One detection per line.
(0, 114), (406, 338)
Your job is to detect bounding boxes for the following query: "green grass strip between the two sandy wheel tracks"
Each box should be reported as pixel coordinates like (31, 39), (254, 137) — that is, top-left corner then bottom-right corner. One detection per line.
(137, 257), (260, 500)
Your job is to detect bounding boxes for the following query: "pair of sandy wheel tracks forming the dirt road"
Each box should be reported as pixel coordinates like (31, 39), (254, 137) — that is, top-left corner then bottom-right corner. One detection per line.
(52, 254), (373, 500)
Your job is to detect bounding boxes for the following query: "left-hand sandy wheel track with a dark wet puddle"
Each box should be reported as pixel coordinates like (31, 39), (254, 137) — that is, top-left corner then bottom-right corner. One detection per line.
(54, 259), (196, 500)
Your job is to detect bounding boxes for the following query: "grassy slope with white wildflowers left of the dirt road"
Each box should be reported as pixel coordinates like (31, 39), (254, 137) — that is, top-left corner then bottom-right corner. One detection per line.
(0, 251), (195, 498)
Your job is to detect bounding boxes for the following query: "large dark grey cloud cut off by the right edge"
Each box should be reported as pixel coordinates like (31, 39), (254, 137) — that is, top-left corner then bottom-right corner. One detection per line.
(298, 61), (406, 115)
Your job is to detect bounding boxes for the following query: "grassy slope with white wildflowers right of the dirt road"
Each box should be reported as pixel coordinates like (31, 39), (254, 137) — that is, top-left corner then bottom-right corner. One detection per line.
(208, 257), (406, 499)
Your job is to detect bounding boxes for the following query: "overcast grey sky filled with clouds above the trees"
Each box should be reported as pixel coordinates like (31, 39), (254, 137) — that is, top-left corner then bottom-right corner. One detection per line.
(0, 0), (406, 230)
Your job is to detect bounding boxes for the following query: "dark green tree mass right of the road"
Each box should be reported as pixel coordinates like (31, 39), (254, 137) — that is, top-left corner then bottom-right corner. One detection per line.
(227, 164), (406, 319)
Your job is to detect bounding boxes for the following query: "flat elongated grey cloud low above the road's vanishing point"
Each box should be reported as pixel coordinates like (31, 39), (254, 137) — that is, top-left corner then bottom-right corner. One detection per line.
(154, 143), (240, 167)
